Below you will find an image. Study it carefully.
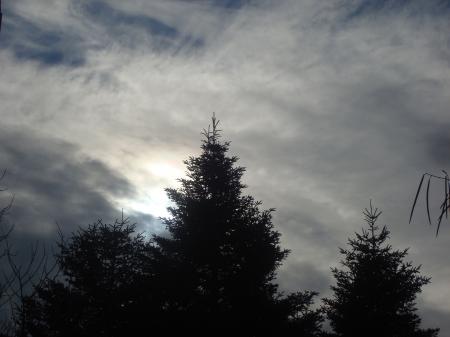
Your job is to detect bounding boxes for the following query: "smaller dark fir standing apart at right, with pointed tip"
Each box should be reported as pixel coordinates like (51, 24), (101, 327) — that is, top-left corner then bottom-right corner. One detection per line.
(324, 205), (438, 337)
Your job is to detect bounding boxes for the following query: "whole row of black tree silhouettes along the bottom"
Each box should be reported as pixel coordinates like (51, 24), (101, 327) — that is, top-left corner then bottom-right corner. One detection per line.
(0, 117), (438, 337)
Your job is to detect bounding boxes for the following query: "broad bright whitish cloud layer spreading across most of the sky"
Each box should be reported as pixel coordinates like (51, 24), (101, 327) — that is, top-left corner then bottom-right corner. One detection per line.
(0, 0), (450, 334)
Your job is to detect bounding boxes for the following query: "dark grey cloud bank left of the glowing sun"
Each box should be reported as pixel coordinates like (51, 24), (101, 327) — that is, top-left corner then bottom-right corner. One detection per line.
(0, 129), (155, 237)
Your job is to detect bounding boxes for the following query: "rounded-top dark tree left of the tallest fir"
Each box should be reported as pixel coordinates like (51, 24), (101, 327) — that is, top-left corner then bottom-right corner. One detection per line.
(22, 218), (159, 337)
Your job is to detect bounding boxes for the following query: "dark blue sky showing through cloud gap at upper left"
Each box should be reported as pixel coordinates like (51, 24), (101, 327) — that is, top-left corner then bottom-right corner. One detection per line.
(0, 1), (204, 67)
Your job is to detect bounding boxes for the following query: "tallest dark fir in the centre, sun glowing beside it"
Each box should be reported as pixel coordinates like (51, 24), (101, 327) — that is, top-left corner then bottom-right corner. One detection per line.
(154, 117), (320, 336)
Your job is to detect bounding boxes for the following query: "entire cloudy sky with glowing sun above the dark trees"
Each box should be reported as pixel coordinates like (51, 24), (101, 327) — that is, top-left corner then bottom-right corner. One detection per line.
(0, 0), (450, 330)
